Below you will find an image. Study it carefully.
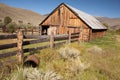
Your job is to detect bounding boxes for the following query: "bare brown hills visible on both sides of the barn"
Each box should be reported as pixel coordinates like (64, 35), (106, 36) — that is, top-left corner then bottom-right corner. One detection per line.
(0, 3), (120, 30)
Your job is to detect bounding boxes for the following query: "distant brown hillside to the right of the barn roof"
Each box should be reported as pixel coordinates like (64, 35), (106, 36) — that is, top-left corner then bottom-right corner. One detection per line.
(96, 17), (120, 30)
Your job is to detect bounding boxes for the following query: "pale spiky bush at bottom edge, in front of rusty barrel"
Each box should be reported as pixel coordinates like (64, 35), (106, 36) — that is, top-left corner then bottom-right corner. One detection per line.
(23, 68), (61, 80)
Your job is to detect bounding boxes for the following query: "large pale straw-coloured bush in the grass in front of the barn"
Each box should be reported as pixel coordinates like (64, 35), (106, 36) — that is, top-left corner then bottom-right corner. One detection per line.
(58, 47), (90, 76)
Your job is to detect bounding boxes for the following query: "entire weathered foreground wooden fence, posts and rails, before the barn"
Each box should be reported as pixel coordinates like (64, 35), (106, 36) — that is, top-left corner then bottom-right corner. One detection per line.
(0, 31), (80, 62)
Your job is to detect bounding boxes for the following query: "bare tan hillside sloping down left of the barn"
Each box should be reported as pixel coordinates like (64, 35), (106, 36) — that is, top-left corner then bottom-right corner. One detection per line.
(0, 3), (45, 26)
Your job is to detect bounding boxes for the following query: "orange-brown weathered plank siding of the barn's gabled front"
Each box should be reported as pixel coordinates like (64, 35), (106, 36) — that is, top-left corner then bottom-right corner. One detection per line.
(42, 5), (90, 41)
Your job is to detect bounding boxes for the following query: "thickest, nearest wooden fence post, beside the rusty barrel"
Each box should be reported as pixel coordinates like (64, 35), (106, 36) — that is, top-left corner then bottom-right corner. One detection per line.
(17, 30), (23, 63)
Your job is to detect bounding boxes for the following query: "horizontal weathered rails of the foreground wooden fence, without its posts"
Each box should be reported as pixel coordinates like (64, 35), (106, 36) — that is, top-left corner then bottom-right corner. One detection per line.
(0, 33), (79, 59)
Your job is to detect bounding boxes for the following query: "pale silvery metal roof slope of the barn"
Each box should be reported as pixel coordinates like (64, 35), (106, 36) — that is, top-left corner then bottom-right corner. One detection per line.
(65, 4), (107, 29)
